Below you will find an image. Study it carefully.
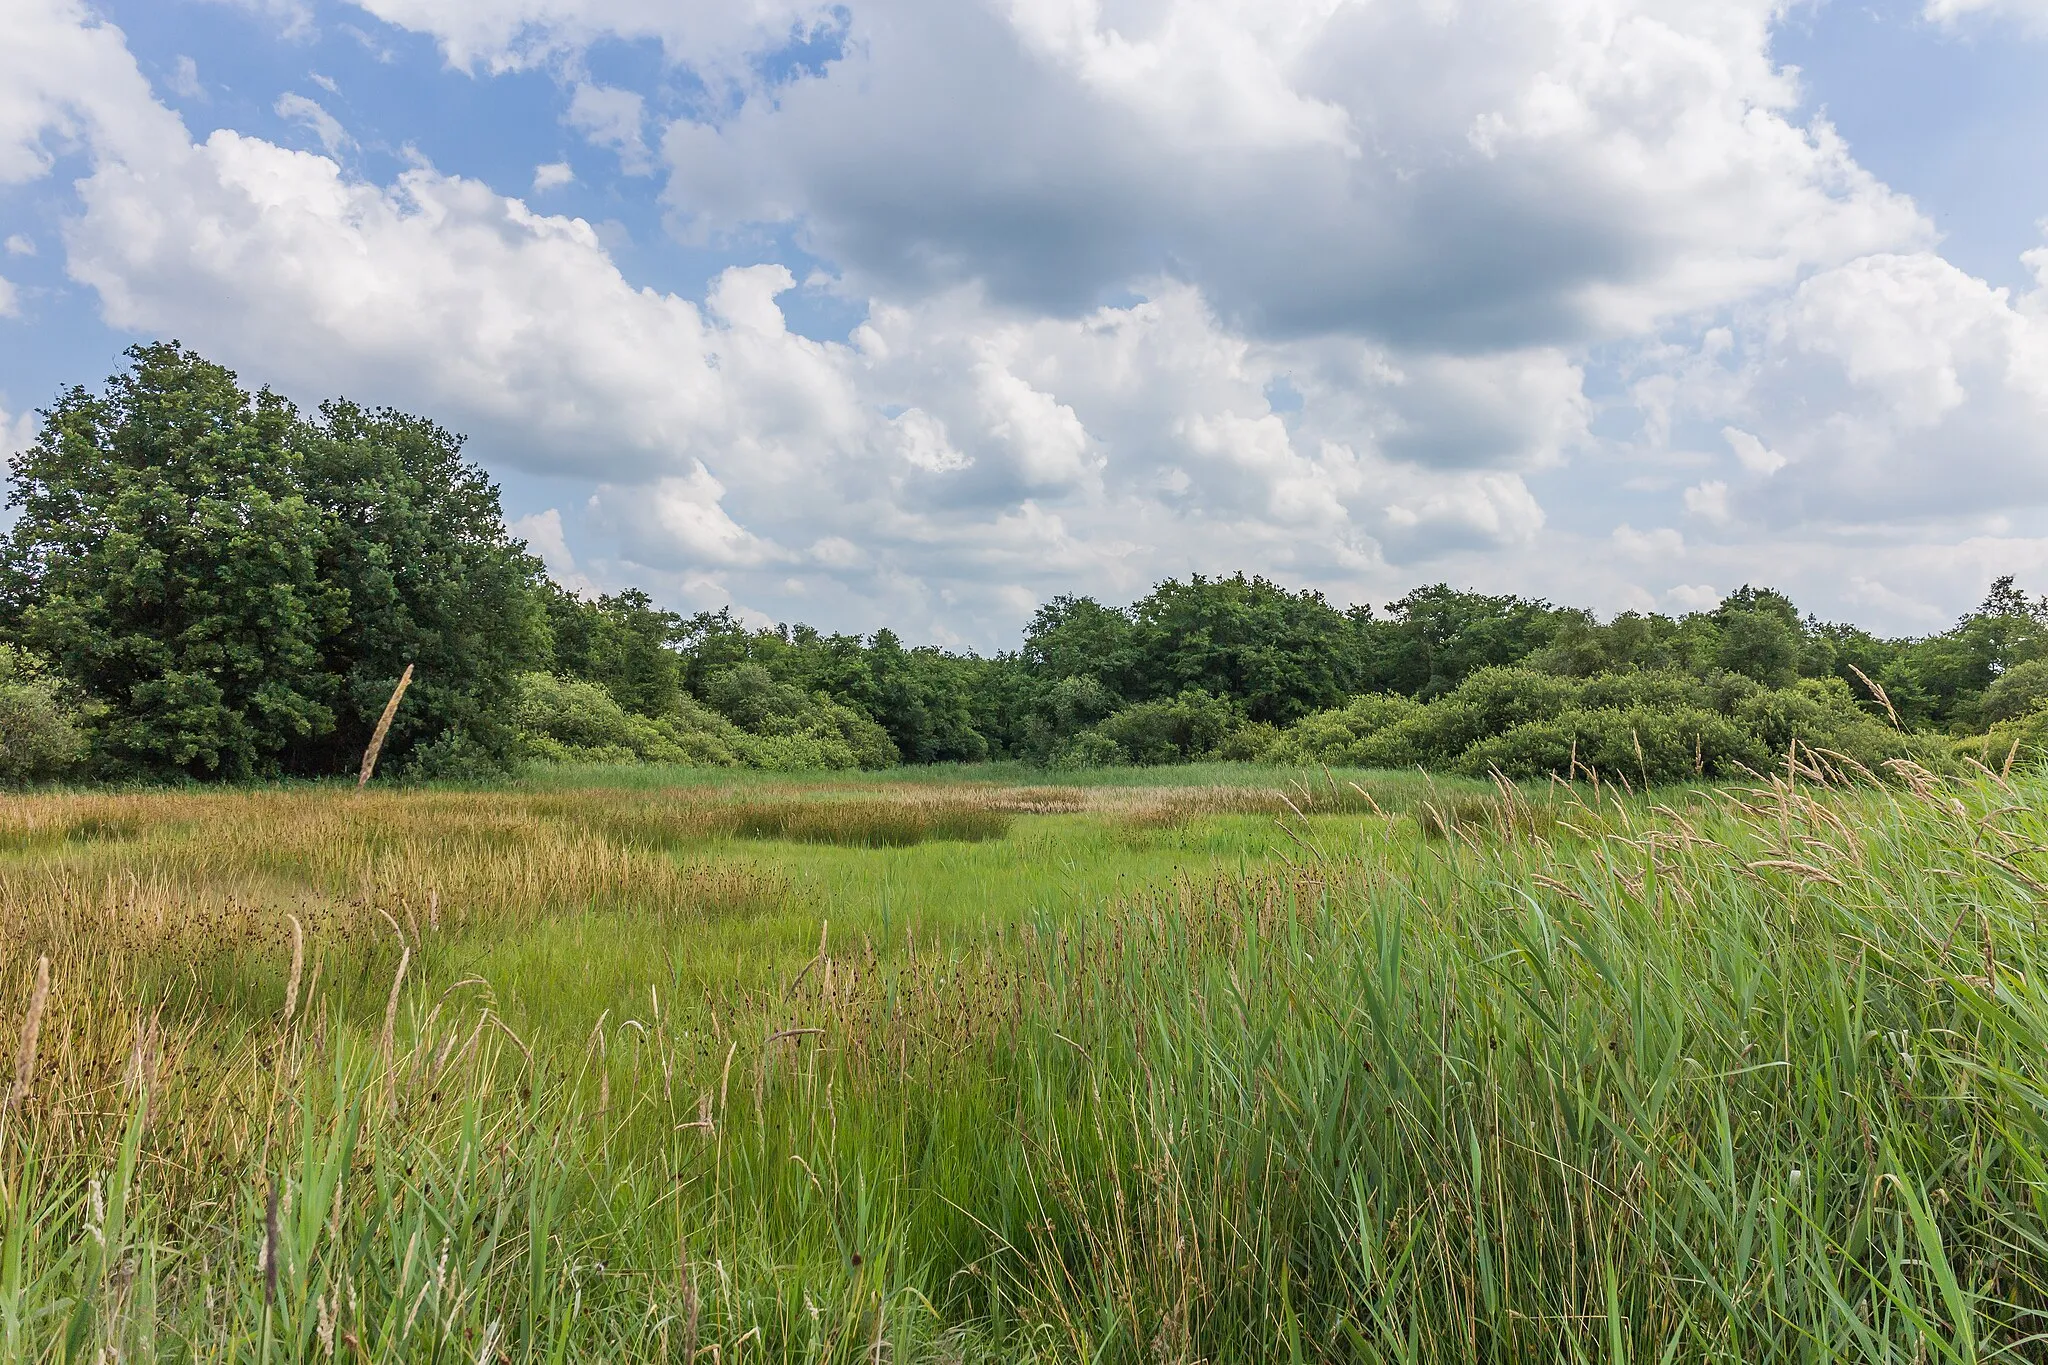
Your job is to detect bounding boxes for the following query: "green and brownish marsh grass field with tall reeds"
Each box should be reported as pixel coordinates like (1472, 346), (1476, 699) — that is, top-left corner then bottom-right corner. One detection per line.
(0, 765), (2048, 1365)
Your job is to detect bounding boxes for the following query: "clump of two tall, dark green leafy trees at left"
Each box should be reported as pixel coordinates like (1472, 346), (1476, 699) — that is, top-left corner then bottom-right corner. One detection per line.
(0, 344), (543, 778)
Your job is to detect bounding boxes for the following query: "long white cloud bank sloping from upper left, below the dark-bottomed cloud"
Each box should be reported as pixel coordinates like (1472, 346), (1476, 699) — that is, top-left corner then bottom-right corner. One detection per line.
(56, 43), (1585, 609)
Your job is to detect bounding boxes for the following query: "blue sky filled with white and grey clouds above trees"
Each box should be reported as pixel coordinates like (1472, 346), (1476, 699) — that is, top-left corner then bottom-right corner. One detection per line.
(0, 0), (2048, 651)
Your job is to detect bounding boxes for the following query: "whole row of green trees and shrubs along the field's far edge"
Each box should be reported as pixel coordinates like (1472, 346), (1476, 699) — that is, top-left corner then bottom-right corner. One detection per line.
(0, 342), (2048, 782)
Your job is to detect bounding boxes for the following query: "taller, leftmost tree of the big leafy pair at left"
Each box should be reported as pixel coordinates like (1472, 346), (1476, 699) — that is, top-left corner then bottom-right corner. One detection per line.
(0, 344), (348, 778)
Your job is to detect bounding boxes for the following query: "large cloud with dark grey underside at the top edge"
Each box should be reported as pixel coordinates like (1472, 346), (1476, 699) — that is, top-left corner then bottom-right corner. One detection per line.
(666, 0), (1929, 348)
